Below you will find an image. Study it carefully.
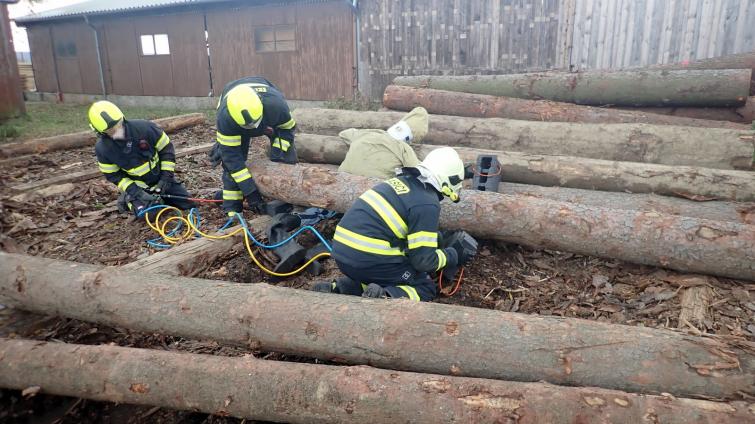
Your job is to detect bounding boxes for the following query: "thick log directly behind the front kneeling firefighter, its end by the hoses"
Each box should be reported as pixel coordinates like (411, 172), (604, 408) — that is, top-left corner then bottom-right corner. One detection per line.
(250, 161), (755, 280)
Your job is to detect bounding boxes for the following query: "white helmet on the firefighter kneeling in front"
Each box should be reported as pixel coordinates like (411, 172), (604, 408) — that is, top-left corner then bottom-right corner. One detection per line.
(417, 147), (464, 203)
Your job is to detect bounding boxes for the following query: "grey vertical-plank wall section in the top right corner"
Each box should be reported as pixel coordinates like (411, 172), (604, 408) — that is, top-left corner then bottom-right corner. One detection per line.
(563, 0), (755, 70)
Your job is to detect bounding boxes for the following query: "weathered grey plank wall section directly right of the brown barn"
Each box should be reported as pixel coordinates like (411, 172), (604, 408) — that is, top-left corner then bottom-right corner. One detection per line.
(359, 0), (560, 97)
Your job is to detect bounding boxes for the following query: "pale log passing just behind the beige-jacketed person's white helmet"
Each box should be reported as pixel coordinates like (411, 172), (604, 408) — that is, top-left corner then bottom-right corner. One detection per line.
(293, 109), (755, 169)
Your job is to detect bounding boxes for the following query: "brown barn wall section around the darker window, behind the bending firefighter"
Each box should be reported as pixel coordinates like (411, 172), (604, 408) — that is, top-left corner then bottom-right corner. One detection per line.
(207, 1), (355, 100)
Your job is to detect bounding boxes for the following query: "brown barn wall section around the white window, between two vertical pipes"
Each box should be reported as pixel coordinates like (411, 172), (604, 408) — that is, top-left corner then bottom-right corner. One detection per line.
(96, 12), (210, 96)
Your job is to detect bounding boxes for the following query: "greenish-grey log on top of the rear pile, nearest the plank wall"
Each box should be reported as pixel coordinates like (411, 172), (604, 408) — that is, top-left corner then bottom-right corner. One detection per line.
(393, 69), (753, 107)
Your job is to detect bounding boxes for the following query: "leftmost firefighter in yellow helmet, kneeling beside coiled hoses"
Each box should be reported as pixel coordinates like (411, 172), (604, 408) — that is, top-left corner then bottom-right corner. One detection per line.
(88, 100), (194, 217)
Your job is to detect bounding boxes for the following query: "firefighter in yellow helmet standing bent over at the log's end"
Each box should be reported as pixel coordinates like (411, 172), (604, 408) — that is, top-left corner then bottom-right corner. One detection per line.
(210, 77), (297, 215)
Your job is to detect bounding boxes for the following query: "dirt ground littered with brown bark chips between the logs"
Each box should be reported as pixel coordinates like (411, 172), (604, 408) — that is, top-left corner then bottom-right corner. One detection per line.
(0, 125), (755, 423)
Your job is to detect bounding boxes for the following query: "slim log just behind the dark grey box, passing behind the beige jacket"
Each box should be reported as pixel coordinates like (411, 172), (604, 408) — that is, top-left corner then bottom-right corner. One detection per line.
(296, 134), (755, 202)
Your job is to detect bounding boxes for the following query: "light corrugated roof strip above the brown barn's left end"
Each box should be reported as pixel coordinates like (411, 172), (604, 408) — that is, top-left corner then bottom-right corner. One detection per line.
(15, 0), (227, 24)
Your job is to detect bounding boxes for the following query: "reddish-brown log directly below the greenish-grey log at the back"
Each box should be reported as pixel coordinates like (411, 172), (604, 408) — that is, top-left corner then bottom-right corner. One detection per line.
(383, 85), (749, 130)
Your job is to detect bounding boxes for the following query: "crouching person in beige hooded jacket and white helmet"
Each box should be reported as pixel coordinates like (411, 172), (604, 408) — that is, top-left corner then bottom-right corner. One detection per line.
(338, 107), (429, 180)
